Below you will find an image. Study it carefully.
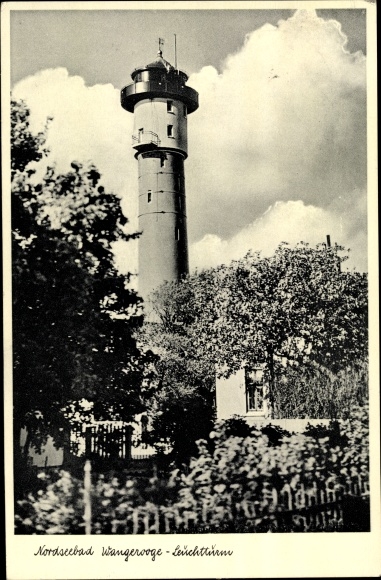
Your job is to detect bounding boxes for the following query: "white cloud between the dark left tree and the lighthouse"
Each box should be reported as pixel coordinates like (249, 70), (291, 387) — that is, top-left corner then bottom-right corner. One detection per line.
(13, 68), (137, 233)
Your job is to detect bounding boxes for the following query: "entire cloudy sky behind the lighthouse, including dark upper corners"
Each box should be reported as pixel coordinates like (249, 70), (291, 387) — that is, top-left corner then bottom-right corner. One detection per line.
(11, 2), (367, 271)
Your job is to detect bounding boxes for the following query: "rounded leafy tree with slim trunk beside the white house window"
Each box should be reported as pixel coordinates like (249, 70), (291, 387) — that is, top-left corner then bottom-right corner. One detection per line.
(197, 243), (368, 405)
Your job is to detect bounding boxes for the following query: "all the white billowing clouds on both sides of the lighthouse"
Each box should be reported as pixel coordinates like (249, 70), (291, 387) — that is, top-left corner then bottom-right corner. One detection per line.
(14, 11), (367, 271)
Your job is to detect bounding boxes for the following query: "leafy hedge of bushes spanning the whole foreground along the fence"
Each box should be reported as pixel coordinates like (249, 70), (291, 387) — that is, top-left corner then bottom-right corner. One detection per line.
(16, 408), (369, 534)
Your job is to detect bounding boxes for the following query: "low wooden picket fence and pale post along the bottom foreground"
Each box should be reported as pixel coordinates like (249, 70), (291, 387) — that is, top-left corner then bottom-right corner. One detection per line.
(84, 461), (369, 534)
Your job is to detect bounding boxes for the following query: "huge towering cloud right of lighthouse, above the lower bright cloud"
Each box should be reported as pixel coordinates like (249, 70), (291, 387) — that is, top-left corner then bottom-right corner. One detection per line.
(187, 11), (366, 238)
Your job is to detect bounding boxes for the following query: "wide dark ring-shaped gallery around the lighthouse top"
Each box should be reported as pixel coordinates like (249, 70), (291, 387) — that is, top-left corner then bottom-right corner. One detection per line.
(120, 79), (198, 113)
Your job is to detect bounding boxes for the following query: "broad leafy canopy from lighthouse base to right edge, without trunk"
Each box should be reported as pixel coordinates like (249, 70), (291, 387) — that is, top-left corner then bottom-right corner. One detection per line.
(148, 243), (368, 376)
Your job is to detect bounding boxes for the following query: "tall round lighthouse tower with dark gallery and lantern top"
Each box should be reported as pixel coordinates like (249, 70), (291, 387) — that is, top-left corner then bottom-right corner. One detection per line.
(121, 44), (198, 300)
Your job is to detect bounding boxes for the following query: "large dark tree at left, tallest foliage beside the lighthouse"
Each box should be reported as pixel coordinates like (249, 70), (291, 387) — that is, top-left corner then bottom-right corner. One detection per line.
(11, 102), (147, 458)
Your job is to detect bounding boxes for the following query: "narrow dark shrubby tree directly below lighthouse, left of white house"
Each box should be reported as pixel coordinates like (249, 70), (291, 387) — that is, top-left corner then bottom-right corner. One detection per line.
(138, 283), (215, 464)
